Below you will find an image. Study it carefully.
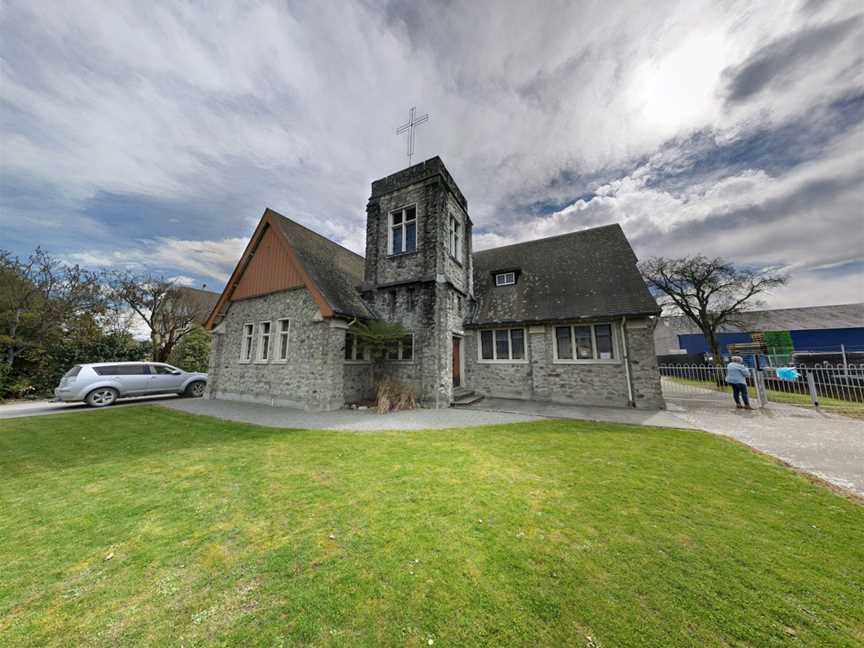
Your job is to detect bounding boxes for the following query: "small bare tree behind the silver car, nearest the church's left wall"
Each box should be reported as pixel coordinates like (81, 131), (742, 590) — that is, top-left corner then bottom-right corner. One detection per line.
(108, 271), (209, 362)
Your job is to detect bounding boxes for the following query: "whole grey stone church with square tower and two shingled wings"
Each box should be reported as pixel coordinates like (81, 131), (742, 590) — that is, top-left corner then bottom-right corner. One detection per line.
(207, 157), (663, 410)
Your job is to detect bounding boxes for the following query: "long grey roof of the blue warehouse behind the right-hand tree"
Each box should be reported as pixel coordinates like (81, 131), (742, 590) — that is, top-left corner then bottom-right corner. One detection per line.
(661, 302), (864, 334)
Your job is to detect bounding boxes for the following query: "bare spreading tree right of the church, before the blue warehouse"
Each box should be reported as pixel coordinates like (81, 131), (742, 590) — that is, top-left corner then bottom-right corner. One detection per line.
(639, 256), (786, 365)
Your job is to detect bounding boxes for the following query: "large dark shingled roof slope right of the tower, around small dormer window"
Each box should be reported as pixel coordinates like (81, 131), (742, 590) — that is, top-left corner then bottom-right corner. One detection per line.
(466, 224), (660, 326)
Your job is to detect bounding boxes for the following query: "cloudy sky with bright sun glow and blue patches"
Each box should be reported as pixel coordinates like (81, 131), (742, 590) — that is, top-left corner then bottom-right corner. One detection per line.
(0, 0), (864, 307)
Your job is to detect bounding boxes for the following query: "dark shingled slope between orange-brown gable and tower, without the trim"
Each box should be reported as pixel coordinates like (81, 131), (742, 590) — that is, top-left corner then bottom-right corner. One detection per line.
(269, 209), (373, 318)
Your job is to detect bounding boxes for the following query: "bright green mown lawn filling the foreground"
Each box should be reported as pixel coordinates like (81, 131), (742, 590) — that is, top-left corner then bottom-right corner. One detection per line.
(0, 406), (864, 648)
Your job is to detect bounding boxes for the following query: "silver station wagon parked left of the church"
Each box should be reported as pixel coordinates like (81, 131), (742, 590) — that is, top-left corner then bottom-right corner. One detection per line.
(54, 362), (207, 407)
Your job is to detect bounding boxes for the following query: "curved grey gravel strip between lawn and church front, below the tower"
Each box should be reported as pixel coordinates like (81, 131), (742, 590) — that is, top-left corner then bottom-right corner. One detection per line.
(160, 398), (542, 432)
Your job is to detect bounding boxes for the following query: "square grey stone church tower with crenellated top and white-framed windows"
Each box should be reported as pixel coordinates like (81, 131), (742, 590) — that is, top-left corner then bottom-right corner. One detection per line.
(362, 156), (473, 407)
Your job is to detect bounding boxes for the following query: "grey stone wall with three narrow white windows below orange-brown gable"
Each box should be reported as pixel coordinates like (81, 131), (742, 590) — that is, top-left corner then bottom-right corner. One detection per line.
(207, 288), (345, 410)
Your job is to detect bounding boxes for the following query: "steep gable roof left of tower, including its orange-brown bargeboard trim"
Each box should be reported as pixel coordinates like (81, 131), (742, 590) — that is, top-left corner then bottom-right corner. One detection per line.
(206, 208), (372, 328)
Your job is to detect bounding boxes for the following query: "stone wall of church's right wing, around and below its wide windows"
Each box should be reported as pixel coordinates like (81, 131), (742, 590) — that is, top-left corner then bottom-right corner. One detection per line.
(465, 320), (664, 409)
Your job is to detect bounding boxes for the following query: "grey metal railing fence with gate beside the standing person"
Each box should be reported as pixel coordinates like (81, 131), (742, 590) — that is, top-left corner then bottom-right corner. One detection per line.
(660, 363), (864, 415)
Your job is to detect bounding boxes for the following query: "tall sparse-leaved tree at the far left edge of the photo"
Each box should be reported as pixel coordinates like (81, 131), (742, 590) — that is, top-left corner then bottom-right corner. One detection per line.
(0, 247), (105, 368)
